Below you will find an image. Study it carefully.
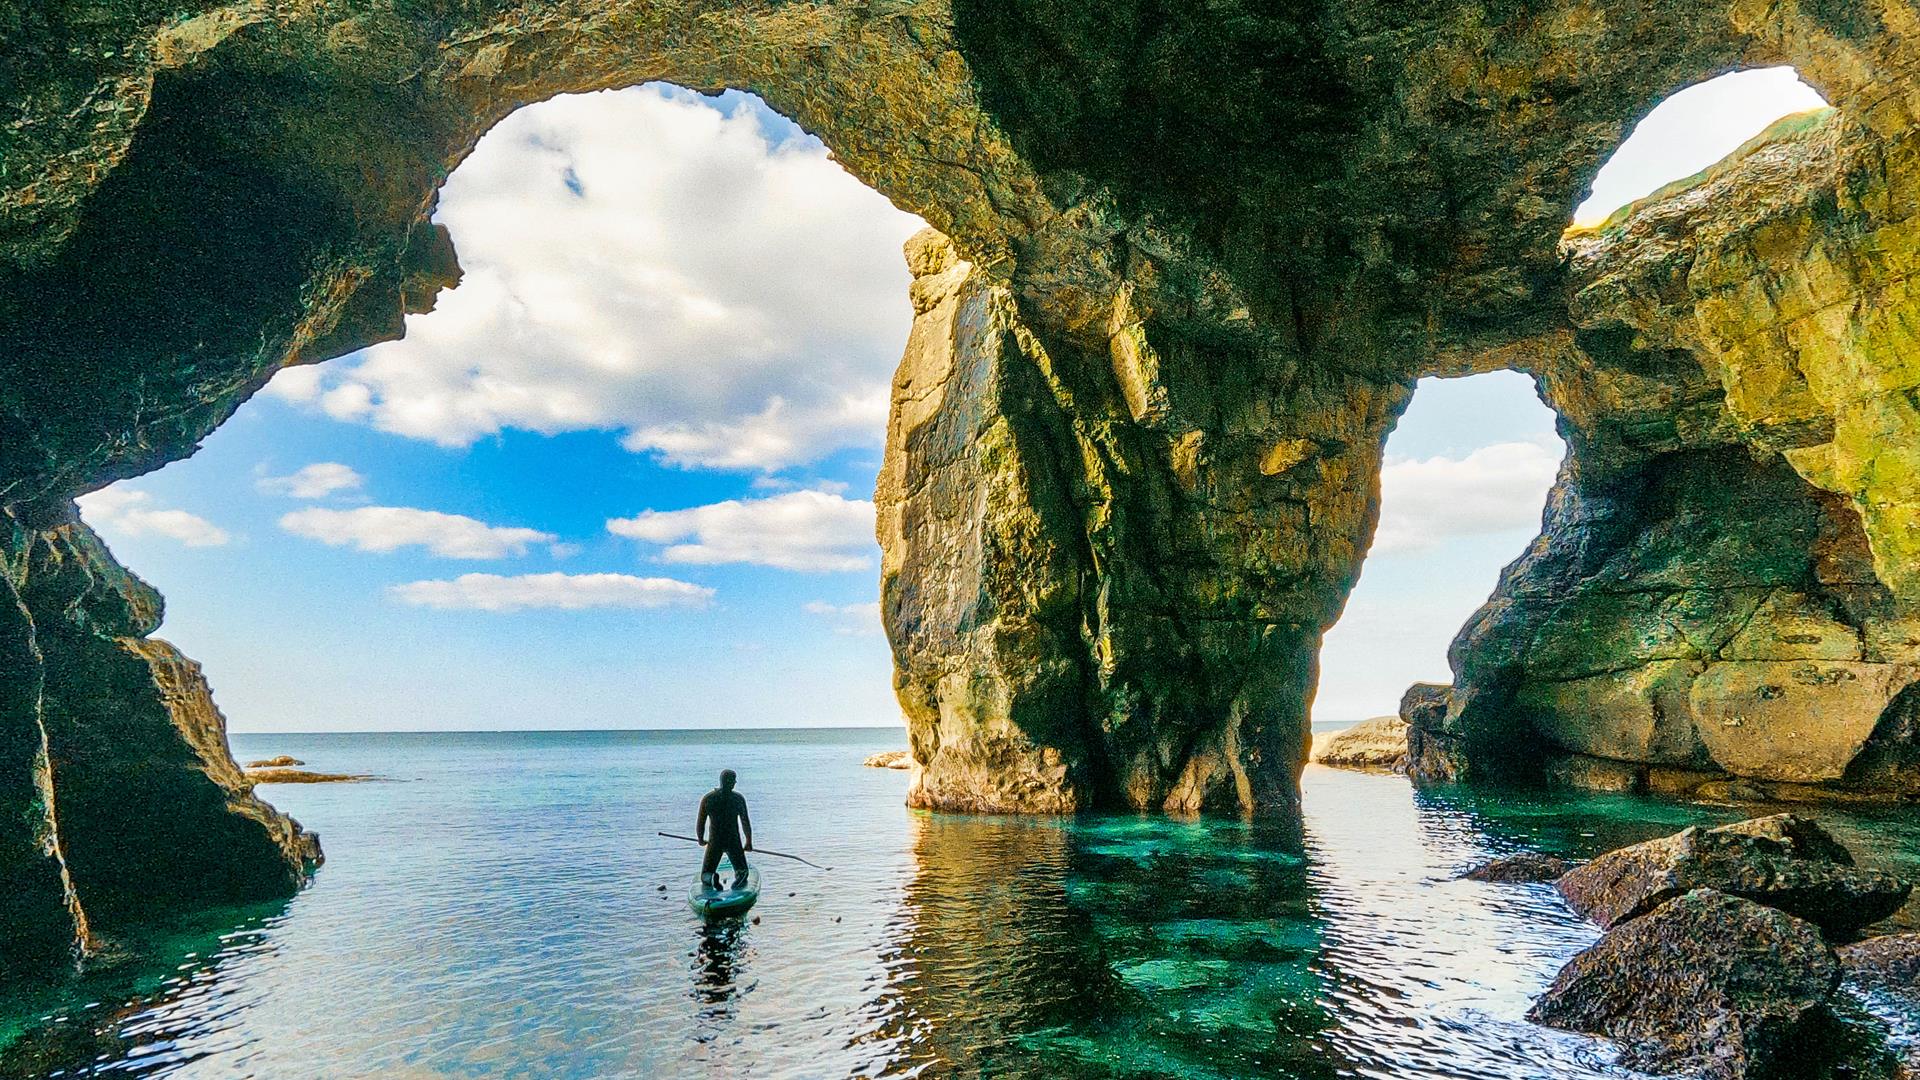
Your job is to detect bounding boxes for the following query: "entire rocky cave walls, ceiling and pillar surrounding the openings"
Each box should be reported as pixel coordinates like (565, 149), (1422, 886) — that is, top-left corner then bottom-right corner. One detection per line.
(0, 0), (1920, 967)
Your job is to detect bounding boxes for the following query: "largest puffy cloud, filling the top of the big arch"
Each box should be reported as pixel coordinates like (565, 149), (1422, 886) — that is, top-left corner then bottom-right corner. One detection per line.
(269, 85), (920, 471)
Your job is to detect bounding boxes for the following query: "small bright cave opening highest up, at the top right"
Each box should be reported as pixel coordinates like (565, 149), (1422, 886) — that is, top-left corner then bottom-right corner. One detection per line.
(1572, 67), (1828, 229)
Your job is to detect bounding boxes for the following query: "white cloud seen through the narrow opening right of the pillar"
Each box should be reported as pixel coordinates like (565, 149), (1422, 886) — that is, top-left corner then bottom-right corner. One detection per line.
(1373, 442), (1561, 555)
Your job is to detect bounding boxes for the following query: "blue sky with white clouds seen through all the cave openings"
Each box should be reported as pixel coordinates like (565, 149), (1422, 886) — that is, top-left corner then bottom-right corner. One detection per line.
(83, 73), (1827, 730)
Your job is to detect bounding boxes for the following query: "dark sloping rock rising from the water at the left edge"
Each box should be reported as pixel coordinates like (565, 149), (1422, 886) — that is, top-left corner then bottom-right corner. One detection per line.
(0, 505), (321, 970)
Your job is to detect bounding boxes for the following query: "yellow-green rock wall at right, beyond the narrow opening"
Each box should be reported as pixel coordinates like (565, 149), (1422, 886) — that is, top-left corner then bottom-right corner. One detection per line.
(1415, 111), (1920, 799)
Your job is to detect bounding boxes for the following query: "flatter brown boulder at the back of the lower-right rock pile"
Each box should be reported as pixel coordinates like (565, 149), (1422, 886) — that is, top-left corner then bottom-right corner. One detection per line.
(1557, 815), (1912, 936)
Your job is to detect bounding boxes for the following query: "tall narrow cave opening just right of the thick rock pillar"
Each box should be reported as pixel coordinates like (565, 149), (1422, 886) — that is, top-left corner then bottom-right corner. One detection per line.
(1313, 371), (1565, 732)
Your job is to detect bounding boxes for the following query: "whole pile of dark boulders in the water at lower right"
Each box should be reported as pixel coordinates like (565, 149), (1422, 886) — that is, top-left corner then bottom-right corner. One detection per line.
(1461, 813), (1920, 1080)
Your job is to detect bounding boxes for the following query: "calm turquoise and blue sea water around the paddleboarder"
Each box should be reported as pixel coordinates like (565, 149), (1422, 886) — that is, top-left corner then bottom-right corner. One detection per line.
(0, 732), (1920, 1078)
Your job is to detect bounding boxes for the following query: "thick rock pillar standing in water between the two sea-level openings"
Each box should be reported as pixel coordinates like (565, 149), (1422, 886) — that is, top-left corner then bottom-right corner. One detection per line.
(876, 233), (1404, 813)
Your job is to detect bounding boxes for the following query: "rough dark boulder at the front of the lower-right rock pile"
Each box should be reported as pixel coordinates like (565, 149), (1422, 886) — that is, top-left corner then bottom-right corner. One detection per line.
(1528, 890), (1839, 1080)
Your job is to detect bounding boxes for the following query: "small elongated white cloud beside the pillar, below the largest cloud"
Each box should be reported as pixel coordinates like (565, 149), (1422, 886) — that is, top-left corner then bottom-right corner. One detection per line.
(607, 492), (876, 571)
